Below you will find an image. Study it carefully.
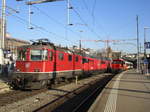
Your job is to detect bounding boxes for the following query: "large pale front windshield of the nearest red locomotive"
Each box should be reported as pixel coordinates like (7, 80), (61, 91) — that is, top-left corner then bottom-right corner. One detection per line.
(30, 50), (47, 61)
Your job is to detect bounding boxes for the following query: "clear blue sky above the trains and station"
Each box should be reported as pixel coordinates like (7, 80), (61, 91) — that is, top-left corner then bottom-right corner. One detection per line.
(0, 0), (150, 53)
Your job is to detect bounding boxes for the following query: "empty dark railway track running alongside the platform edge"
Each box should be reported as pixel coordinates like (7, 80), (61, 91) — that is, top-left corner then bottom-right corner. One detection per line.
(34, 75), (113, 112)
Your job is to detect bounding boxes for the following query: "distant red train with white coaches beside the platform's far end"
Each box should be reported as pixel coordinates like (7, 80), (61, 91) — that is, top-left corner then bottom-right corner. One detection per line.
(111, 59), (133, 73)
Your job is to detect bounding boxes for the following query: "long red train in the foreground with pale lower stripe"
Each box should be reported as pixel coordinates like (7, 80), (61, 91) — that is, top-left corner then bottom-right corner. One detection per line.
(11, 39), (110, 89)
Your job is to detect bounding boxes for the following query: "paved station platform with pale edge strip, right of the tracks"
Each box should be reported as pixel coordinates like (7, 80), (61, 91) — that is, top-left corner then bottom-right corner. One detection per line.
(88, 70), (150, 112)
